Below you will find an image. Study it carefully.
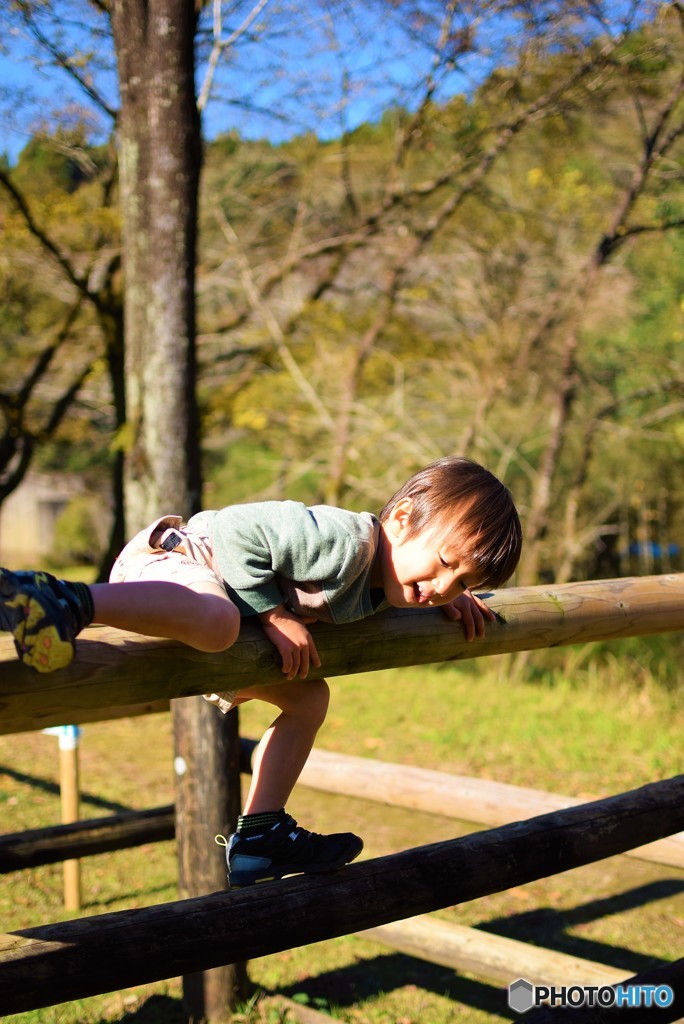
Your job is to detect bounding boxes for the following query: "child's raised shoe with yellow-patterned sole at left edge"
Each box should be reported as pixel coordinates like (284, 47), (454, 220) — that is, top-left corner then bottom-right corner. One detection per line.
(0, 568), (92, 672)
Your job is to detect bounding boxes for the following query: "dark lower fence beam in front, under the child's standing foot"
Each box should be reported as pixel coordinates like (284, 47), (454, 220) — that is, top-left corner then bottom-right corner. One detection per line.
(0, 775), (684, 1014)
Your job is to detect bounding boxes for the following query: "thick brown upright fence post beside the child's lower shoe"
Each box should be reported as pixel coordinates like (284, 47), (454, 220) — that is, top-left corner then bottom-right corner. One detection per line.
(171, 697), (247, 1024)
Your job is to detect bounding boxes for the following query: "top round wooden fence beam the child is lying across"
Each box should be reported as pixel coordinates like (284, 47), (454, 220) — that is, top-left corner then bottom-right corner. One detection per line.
(0, 573), (684, 733)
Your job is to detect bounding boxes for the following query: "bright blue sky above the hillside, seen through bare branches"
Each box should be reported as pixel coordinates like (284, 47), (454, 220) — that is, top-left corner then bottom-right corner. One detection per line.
(0, 0), (650, 162)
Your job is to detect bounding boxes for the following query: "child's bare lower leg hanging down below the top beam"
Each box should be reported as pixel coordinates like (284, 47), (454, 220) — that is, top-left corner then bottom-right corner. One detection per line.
(240, 679), (330, 814)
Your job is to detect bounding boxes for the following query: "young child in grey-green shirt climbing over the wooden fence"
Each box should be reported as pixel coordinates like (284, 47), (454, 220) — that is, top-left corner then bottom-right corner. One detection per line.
(0, 457), (522, 887)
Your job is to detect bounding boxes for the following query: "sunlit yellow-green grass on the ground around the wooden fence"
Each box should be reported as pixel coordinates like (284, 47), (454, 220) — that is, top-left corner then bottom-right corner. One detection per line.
(0, 644), (684, 1024)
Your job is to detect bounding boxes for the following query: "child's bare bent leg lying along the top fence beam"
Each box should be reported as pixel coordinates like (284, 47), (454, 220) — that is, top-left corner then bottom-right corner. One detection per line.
(90, 580), (240, 651)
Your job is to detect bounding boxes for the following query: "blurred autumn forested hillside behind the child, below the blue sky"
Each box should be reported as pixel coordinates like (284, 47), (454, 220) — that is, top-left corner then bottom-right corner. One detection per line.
(0, 4), (684, 584)
